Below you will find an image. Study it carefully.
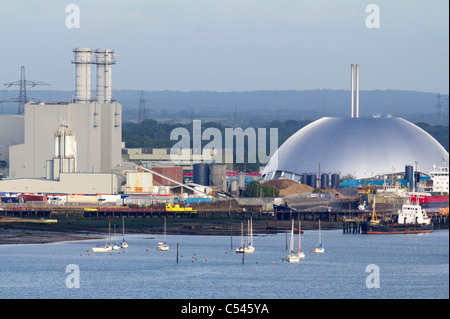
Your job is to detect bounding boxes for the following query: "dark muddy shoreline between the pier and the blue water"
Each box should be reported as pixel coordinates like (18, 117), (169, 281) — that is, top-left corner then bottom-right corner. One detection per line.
(0, 218), (342, 245)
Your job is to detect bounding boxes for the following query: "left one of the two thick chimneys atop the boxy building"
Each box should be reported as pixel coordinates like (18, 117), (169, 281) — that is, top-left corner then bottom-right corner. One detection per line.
(72, 48), (92, 103)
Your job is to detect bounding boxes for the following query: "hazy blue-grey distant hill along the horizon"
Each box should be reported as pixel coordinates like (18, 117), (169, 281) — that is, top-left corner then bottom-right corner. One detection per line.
(0, 89), (449, 125)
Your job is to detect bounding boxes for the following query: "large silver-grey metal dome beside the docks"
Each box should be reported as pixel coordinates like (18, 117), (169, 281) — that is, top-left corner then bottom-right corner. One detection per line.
(262, 117), (448, 180)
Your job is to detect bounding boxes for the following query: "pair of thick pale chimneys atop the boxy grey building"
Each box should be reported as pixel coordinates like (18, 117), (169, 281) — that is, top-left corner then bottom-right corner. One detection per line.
(72, 48), (116, 103)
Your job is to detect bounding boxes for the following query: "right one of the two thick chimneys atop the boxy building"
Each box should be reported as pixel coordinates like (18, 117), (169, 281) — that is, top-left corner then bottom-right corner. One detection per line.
(94, 49), (116, 103)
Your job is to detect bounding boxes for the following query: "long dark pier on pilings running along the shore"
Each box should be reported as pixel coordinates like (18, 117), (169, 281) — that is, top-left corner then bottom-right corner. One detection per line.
(0, 206), (449, 234)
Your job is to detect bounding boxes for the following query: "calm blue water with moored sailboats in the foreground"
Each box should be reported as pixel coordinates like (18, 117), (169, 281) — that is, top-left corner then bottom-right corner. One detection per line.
(0, 230), (449, 299)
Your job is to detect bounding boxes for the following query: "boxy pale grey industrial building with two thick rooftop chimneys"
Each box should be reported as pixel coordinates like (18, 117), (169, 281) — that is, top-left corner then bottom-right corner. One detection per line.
(0, 48), (122, 193)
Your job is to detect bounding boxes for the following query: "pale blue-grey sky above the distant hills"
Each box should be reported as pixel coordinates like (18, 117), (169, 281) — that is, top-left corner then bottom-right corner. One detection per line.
(0, 0), (449, 94)
